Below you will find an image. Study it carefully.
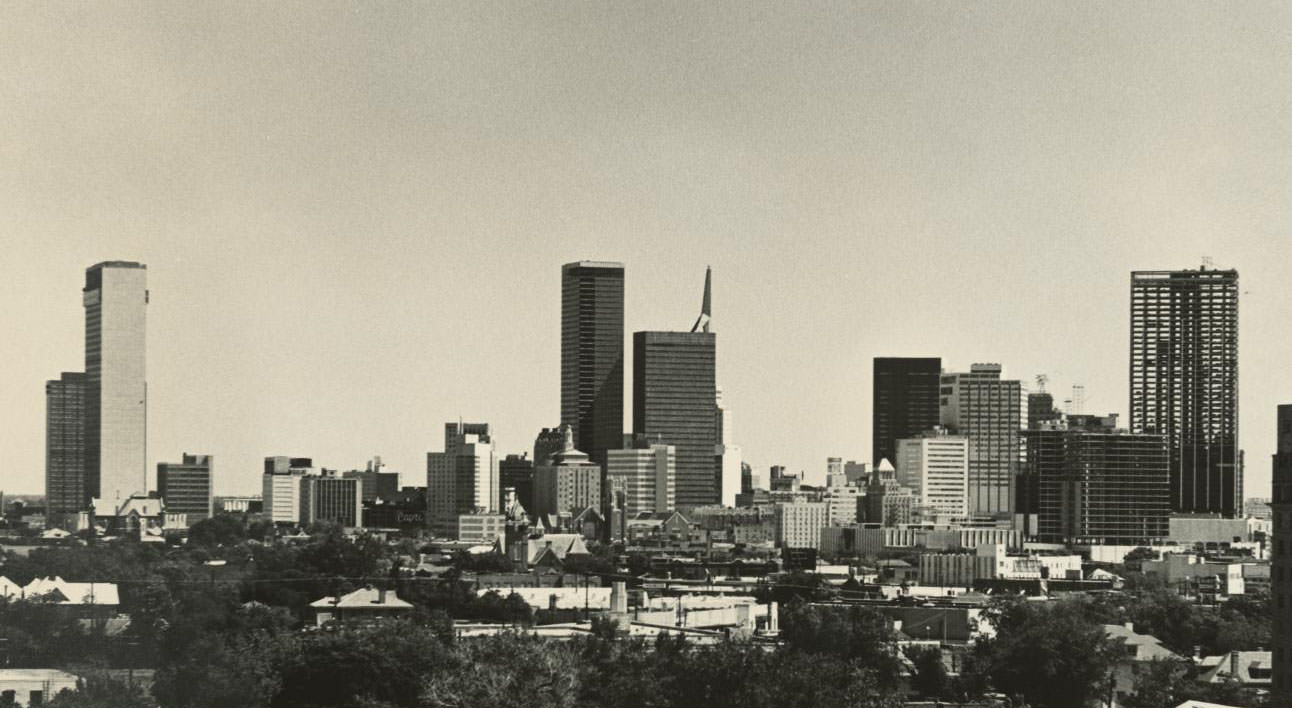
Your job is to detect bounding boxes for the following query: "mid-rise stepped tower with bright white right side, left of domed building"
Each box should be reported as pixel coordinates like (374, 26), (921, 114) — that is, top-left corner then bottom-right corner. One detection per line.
(426, 422), (499, 536)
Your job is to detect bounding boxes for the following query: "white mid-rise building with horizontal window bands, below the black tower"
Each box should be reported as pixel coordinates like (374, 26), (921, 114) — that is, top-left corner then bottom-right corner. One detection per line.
(895, 426), (969, 518)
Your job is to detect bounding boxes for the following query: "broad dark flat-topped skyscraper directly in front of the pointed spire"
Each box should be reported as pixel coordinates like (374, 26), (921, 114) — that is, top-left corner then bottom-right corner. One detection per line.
(633, 332), (722, 509)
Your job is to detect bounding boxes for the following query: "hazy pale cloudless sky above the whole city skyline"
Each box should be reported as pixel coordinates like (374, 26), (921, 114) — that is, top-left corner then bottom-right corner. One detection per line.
(0, 0), (1292, 496)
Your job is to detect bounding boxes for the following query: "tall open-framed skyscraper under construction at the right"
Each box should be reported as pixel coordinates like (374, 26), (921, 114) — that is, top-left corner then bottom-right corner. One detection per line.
(1131, 266), (1243, 517)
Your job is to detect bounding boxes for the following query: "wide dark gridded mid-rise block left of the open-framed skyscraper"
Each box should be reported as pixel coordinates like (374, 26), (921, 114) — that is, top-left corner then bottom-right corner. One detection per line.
(1019, 415), (1171, 545)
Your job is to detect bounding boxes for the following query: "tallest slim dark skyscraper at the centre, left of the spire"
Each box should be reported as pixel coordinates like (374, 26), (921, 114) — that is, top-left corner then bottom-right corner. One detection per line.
(560, 261), (624, 465)
